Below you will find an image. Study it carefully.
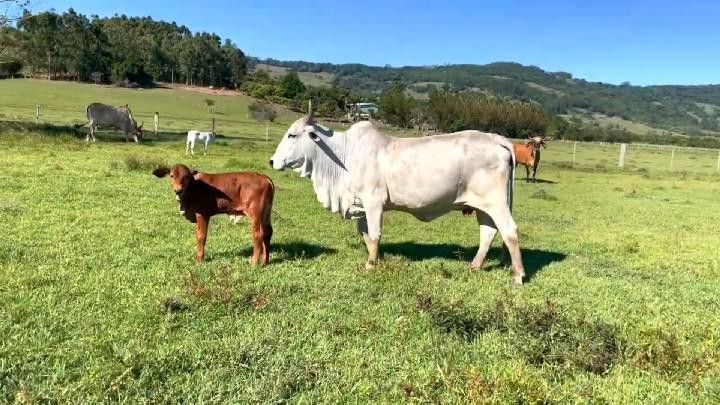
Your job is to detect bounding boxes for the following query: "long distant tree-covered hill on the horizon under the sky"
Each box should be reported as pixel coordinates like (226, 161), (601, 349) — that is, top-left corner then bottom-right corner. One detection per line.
(257, 60), (720, 135)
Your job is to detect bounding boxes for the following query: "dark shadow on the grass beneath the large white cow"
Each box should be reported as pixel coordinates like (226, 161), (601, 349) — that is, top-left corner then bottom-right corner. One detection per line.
(380, 242), (567, 282)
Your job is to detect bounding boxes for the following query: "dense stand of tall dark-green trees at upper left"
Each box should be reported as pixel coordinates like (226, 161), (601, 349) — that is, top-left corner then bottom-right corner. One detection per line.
(3, 9), (247, 88)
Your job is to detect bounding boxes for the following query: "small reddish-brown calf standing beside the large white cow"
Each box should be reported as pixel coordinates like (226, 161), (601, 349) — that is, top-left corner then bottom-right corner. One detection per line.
(153, 164), (275, 265)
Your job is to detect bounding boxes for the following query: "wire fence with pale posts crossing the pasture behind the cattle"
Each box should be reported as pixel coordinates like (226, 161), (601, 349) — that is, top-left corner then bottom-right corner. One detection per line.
(0, 100), (720, 173)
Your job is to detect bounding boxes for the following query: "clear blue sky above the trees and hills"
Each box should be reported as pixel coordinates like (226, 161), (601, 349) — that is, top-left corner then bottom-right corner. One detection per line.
(35, 0), (720, 85)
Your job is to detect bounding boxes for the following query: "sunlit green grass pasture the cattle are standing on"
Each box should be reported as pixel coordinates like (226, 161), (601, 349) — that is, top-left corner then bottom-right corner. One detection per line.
(0, 81), (720, 404)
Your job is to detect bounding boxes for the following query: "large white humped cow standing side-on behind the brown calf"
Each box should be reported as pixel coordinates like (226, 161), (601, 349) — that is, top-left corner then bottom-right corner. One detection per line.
(270, 104), (525, 284)
